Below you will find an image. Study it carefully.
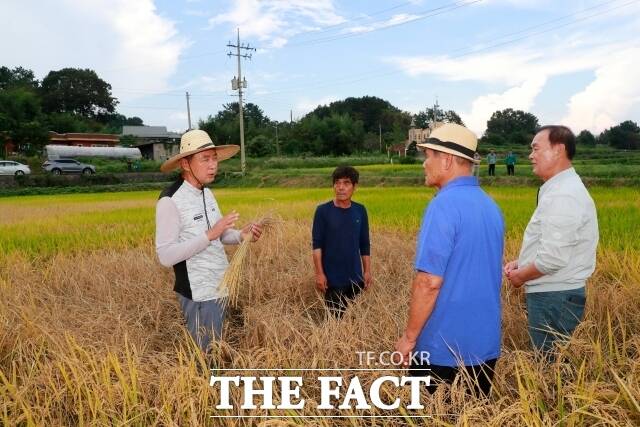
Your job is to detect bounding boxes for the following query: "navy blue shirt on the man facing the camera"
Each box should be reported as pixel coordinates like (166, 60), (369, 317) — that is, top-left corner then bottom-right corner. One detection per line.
(311, 200), (370, 289)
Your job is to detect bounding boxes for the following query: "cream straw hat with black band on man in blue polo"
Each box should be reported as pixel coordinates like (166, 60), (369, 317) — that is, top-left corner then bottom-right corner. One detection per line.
(417, 123), (480, 163)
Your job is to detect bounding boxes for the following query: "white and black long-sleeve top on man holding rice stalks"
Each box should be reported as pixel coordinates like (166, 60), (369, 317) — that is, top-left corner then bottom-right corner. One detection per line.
(156, 180), (241, 301)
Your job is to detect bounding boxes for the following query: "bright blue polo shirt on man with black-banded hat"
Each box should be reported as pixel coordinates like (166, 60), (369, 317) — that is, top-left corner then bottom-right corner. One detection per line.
(415, 176), (504, 366)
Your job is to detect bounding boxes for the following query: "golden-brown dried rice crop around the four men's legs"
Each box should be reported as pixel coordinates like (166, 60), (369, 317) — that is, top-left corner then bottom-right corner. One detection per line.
(0, 221), (640, 426)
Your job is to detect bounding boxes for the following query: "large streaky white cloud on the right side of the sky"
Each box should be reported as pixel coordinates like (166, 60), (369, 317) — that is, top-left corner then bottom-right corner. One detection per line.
(385, 26), (640, 134)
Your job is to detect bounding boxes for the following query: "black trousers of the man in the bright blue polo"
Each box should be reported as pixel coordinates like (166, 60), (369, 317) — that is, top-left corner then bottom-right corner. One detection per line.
(409, 359), (498, 397)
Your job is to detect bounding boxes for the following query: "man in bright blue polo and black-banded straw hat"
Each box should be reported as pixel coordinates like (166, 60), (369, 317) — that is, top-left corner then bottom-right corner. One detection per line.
(396, 123), (504, 395)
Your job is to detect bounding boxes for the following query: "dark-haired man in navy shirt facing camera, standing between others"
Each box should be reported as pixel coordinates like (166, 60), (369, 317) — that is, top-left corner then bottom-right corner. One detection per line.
(312, 166), (372, 318)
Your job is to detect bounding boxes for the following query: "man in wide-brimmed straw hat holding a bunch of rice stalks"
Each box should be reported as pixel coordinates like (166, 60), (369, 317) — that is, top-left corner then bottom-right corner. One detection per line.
(156, 130), (261, 351)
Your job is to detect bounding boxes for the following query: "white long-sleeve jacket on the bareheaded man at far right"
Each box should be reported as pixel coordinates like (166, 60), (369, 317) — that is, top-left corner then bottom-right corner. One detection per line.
(518, 168), (599, 292)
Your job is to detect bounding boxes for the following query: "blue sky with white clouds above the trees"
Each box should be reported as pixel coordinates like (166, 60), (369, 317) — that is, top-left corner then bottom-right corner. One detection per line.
(0, 0), (640, 133)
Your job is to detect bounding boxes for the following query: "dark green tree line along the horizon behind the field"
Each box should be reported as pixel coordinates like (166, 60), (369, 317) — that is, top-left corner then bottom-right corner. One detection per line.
(0, 67), (640, 157)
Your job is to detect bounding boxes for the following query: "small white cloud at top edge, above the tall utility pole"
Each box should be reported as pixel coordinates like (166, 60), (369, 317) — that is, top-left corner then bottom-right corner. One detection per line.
(209, 0), (345, 48)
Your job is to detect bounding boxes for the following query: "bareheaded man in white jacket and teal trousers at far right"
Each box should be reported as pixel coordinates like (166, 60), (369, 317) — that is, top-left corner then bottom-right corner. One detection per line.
(504, 126), (599, 356)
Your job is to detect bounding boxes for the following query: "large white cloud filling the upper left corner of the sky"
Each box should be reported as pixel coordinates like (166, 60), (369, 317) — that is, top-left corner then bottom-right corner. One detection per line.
(0, 0), (188, 100)
